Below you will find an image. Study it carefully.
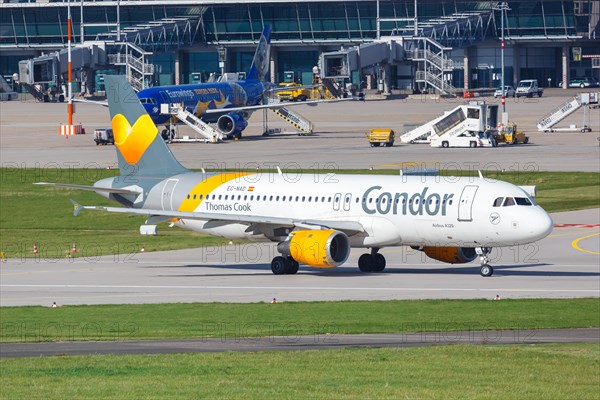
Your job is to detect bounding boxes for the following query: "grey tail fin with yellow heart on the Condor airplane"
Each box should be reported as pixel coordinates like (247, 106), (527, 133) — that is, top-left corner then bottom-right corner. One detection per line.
(105, 75), (188, 177)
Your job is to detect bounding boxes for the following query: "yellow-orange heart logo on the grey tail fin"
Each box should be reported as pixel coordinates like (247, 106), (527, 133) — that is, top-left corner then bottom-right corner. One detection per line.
(112, 114), (158, 165)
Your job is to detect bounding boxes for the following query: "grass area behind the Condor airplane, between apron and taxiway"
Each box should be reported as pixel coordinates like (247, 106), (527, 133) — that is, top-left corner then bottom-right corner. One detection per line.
(0, 168), (600, 258)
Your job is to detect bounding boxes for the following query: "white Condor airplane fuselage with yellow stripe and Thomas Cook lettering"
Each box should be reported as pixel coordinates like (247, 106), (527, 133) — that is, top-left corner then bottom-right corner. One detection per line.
(101, 173), (552, 247)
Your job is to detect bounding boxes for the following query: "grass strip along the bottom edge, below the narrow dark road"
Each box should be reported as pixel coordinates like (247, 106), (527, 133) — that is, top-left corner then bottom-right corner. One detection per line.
(0, 343), (600, 400)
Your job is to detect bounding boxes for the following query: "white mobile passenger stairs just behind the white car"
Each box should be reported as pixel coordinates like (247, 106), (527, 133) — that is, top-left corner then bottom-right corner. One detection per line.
(400, 101), (498, 143)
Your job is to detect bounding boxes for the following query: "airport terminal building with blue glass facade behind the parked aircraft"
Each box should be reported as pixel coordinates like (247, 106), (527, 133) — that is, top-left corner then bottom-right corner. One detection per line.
(0, 0), (600, 91)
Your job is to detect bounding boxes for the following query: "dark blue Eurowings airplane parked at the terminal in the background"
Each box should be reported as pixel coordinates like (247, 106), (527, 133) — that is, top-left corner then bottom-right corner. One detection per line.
(137, 25), (282, 139)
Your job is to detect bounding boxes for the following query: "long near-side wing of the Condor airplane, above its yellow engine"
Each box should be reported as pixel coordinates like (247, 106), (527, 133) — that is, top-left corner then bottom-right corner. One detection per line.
(71, 200), (365, 235)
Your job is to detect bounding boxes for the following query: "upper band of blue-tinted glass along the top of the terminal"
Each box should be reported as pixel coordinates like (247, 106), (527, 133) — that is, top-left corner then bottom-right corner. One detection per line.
(0, 0), (600, 46)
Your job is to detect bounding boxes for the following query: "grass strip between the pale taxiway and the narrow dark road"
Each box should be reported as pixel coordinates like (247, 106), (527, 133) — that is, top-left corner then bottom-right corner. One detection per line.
(0, 298), (600, 342)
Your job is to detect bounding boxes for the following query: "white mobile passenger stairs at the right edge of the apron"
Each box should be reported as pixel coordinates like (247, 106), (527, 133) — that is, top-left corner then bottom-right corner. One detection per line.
(537, 93), (600, 132)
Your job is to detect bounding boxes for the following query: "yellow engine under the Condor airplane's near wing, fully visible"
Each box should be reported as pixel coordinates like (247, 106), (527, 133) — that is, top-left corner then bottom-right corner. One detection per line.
(277, 229), (350, 268)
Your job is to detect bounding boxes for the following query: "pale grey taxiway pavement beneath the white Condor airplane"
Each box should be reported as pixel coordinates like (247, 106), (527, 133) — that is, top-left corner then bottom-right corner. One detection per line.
(0, 209), (600, 306)
